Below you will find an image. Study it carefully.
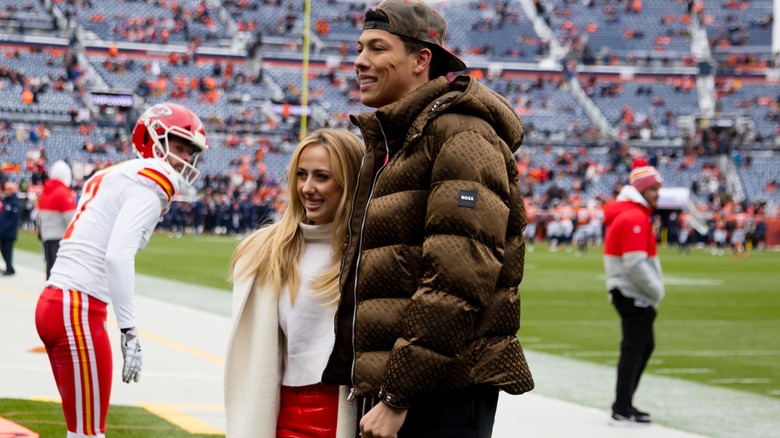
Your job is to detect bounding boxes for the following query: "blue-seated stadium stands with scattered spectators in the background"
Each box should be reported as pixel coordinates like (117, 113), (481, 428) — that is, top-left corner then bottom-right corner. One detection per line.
(0, 0), (780, 246)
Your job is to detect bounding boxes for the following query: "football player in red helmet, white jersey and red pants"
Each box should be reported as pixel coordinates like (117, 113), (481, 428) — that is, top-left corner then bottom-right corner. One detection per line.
(35, 103), (208, 438)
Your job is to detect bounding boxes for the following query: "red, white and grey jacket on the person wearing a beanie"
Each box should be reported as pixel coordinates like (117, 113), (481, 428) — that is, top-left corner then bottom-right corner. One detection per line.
(604, 185), (665, 308)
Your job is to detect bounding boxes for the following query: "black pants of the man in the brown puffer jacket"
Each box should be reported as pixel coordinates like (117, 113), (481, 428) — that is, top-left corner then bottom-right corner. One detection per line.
(357, 385), (498, 438)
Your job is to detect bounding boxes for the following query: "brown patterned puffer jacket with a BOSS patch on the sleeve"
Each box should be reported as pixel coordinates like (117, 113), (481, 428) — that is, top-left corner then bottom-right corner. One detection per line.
(323, 76), (533, 408)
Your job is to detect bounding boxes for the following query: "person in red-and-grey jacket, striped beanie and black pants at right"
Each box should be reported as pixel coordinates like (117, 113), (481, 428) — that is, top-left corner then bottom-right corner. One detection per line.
(604, 160), (664, 425)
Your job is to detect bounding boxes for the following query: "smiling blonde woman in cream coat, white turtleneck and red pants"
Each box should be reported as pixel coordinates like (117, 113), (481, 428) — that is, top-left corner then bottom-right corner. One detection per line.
(225, 129), (365, 438)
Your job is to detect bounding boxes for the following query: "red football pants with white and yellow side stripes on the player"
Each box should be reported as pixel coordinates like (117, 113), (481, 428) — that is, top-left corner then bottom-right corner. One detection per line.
(35, 287), (113, 436)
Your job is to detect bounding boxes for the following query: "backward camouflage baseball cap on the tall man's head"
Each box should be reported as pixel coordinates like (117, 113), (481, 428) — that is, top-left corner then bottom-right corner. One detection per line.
(363, 0), (466, 71)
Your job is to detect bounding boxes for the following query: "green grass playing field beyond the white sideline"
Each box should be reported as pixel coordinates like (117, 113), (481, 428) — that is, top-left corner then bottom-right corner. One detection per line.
(17, 233), (780, 398)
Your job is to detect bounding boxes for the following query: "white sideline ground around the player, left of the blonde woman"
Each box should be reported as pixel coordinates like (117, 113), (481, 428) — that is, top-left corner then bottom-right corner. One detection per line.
(0, 251), (230, 435)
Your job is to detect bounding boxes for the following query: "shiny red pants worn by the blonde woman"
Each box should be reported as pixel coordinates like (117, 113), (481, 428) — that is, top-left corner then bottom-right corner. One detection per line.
(276, 383), (339, 438)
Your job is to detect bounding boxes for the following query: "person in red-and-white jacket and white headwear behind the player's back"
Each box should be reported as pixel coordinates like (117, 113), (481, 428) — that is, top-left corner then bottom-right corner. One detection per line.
(37, 160), (76, 280)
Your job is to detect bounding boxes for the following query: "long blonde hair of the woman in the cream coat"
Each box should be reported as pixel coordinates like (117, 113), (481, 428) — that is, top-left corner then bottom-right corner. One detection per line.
(231, 128), (365, 305)
